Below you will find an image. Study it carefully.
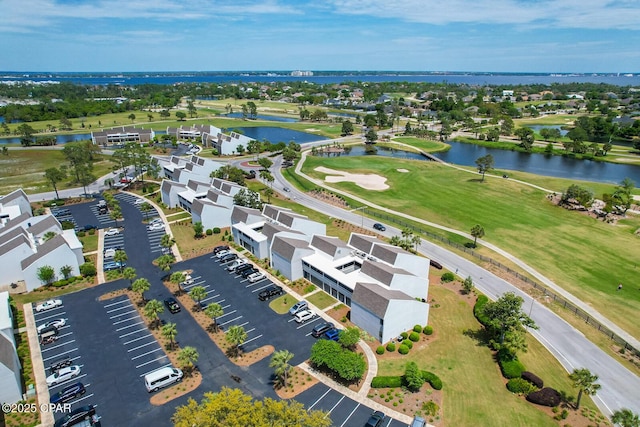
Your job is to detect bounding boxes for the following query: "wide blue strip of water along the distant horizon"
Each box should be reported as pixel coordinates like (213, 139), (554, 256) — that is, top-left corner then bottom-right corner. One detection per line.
(0, 72), (640, 86)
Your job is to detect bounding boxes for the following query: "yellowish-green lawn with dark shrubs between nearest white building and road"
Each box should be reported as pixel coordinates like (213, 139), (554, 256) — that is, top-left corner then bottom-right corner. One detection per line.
(378, 285), (594, 427)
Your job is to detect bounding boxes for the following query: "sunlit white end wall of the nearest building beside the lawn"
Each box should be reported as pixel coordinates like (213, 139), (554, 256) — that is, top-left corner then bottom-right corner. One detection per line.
(380, 300), (429, 343)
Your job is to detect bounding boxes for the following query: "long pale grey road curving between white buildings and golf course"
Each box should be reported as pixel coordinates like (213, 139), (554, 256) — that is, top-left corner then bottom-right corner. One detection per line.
(273, 157), (640, 414)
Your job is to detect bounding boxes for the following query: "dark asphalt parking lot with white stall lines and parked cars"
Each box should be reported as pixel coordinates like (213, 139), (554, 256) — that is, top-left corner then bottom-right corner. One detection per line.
(36, 193), (404, 426)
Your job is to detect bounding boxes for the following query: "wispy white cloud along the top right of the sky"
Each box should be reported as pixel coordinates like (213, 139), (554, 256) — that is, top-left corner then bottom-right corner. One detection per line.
(328, 0), (640, 30)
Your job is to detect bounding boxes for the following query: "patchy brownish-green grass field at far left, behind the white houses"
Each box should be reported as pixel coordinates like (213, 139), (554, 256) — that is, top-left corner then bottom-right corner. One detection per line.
(0, 149), (113, 194)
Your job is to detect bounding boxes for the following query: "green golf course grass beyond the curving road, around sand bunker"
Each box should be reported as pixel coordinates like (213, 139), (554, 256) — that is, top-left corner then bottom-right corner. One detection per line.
(304, 157), (640, 336)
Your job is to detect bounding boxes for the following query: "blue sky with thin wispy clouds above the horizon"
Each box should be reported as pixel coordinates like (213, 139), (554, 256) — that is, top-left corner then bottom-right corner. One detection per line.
(0, 0), (640, 73)
